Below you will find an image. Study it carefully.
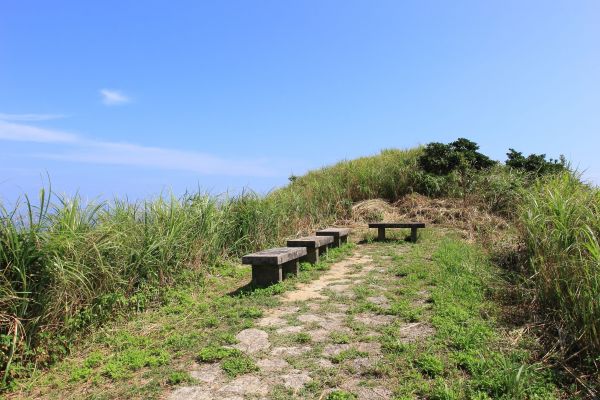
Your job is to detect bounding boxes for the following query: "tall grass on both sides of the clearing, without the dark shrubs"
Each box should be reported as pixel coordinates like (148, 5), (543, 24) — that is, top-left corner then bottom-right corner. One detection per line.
(0, 145), (600, 396)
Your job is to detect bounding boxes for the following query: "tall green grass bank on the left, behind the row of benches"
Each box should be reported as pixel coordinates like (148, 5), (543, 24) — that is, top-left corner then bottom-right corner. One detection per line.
(0, 149), (419, 385)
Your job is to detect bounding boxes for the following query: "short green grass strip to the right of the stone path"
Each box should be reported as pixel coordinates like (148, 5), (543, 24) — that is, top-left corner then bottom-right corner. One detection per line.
(366, 234), (562, 400)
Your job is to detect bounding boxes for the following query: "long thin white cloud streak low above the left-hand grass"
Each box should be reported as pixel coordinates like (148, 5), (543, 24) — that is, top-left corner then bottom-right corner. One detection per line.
(0, 121), (275, 176)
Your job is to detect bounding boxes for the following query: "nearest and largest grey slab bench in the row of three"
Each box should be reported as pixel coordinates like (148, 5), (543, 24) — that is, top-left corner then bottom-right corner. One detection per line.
(242, 247), (306, 286)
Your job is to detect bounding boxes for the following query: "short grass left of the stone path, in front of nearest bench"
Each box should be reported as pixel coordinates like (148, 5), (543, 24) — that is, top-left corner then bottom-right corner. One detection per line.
(3, 244), (354, 399)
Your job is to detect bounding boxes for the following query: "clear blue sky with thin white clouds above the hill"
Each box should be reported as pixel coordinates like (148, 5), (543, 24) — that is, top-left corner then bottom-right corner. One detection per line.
(0, 0), (600, 202)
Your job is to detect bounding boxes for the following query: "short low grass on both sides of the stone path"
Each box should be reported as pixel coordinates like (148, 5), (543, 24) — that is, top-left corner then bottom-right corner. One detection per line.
(10, 229), (560, 399)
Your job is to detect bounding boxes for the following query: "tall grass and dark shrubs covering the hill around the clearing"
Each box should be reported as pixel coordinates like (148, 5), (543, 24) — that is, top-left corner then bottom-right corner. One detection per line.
(0, 140), (600, 393)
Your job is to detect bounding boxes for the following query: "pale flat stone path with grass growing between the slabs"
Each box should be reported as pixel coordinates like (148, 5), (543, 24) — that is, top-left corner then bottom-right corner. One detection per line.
(168, 245), (432, 400)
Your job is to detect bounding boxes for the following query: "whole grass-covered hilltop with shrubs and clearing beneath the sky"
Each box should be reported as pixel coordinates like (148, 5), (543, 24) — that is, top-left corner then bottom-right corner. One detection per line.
(0, 139), (600, 398)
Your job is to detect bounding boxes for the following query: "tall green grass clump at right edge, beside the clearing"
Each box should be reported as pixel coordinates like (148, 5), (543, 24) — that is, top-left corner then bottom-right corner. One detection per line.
(521, 172), (600, 355)
